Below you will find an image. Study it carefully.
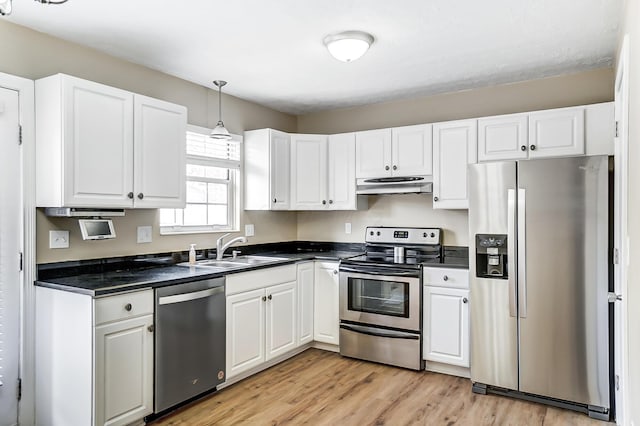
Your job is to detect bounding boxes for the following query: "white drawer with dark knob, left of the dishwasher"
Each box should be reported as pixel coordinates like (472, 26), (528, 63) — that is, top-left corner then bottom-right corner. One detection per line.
(95, 290), (153, 325)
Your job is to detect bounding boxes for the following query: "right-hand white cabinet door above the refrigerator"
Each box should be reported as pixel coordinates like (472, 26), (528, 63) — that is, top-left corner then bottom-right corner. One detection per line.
(529, 107), (584, 158)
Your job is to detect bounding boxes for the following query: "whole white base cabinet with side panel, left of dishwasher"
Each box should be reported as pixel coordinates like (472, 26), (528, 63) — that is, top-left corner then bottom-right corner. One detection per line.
(35, 287), (154, 426)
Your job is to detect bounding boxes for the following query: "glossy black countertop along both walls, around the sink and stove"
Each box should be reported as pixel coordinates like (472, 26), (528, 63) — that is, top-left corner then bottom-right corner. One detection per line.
(35, 242), (469, 297)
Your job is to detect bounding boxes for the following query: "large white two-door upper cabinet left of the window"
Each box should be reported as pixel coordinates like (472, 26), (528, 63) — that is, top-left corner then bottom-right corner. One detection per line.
(36, 74), (187, 208)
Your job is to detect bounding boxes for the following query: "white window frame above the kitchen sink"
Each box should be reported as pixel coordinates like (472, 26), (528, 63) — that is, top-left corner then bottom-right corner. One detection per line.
(158, 124), (244, 235)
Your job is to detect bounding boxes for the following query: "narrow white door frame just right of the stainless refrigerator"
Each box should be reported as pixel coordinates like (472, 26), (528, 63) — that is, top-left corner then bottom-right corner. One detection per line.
(613, 35), (629, 424)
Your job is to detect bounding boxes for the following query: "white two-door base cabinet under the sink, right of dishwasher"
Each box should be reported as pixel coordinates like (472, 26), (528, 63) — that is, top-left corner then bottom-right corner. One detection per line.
(226, 265), (298, 378)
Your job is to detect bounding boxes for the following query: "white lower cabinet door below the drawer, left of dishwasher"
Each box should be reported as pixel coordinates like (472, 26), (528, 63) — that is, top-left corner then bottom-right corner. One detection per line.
(94, 315), (153, 425)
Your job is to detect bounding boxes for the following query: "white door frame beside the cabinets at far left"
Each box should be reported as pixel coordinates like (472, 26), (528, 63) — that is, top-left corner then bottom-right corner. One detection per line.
(0, 72), (36, 425)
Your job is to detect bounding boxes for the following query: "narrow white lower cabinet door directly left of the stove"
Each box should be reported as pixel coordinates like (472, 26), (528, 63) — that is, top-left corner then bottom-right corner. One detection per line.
(313, 262), (340, 345)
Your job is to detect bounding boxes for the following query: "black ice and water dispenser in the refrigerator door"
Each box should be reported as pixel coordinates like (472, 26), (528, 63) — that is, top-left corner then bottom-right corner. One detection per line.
(476, 234), (509, 280)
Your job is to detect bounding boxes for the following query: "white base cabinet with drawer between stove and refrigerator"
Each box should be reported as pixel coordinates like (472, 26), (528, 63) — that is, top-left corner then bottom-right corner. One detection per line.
(422, 267), (470, 374)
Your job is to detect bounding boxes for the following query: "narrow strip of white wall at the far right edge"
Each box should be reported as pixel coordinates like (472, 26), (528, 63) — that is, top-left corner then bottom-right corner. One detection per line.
(620, 0), (640, 426)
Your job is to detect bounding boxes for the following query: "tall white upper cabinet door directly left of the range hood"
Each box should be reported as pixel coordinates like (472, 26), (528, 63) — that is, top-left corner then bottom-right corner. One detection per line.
(327, 133), (357, 210)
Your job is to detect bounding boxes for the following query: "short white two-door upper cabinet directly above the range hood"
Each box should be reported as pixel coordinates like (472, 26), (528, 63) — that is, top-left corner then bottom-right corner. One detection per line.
(356, 124), (432, 178)
